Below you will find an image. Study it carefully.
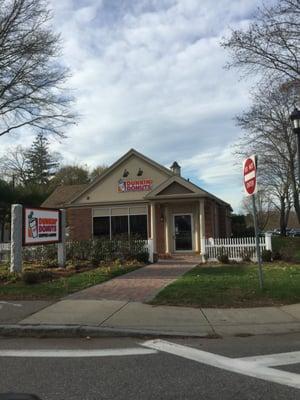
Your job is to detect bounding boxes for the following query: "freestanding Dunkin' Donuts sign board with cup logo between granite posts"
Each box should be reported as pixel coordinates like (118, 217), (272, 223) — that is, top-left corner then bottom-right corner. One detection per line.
(23, 207), (61, 246)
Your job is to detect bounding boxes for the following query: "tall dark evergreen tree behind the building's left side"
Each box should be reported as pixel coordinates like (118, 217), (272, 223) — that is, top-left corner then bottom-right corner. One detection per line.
(27, 133), (59, 186)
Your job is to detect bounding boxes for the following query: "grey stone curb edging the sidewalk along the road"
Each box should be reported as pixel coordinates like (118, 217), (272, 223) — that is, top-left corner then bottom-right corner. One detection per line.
(0, 324), (221, 339)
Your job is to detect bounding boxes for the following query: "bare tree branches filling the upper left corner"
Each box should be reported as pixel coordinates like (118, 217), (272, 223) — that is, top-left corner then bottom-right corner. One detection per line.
(0, 0), (74, 136)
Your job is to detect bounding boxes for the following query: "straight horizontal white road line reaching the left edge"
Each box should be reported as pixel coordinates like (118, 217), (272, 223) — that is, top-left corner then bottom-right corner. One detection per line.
(0, 347), (157, 358)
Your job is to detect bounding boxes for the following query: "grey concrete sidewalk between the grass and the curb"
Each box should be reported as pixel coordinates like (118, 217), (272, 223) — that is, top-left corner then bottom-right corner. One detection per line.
(0, 299), (300, 337)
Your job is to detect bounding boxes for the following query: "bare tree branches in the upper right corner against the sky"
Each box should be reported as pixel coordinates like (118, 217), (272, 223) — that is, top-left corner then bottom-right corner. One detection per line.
(222, 0), (300, 81)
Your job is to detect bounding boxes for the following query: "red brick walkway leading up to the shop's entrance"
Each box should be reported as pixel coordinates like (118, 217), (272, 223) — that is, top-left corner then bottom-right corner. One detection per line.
(68, 263), (196, 302)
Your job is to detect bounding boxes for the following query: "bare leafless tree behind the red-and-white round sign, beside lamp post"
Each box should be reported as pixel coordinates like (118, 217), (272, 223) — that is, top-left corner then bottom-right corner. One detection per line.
(235, 86), (300, 227)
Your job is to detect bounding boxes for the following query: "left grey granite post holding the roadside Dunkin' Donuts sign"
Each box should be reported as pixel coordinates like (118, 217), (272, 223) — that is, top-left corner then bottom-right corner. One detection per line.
(10, 204), (23, 272)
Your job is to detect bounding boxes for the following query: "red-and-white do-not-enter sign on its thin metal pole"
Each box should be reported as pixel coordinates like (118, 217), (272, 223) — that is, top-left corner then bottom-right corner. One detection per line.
(243, 155), (264, 289)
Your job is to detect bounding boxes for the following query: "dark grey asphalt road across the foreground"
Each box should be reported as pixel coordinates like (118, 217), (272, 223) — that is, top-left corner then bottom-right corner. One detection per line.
(0, 334), (300, 400)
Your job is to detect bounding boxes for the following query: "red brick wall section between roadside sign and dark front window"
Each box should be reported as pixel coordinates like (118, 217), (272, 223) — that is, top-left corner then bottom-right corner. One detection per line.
(67, 208), (92, 240)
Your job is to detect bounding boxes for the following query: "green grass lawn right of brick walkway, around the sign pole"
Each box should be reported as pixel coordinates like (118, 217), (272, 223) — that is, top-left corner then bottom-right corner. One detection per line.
(151, 262), (300, 307)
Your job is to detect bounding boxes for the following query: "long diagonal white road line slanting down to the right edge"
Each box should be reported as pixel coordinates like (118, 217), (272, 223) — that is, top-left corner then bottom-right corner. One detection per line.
(143, 339), (300, 389)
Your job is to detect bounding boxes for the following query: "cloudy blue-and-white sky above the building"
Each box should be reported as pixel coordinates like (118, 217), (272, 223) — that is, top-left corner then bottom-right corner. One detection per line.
(0, 0), (260, 211)
